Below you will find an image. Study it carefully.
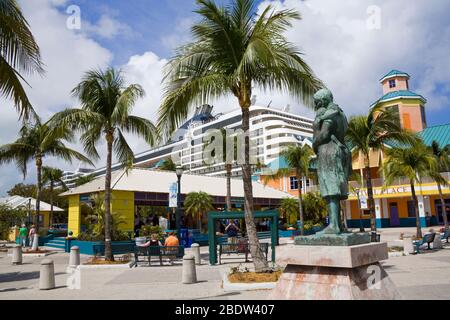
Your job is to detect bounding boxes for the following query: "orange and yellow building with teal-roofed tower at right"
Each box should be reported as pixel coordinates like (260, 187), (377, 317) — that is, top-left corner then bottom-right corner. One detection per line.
(262, 70), (450, 228)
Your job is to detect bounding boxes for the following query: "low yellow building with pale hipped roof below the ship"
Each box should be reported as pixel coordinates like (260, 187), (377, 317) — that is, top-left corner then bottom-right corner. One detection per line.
(62, 168), (290, 237)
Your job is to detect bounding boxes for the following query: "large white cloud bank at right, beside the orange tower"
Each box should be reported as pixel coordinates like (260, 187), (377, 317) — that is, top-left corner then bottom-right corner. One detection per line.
(250, 0), (450, 114)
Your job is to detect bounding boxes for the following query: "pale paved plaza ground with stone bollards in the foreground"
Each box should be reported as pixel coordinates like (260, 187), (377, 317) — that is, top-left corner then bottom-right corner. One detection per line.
(0, 228), (450, 300)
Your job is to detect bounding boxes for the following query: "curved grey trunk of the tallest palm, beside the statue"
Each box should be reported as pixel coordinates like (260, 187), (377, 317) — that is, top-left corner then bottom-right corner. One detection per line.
(240, 104), (269, 272)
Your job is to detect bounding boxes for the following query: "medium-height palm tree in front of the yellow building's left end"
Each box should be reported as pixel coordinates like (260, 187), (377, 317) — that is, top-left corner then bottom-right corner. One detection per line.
(52, 68), (156, 261)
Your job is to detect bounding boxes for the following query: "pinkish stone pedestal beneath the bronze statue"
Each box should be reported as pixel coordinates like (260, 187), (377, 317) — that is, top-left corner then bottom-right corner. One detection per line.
(269, 243), (401, 300)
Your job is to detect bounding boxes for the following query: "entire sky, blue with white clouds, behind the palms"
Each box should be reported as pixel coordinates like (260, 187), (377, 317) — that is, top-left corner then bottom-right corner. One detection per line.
(0, 0), (450, 195)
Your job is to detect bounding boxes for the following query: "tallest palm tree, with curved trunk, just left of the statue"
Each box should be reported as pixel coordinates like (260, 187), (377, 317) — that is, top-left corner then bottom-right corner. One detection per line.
(158, 0), (322, 272)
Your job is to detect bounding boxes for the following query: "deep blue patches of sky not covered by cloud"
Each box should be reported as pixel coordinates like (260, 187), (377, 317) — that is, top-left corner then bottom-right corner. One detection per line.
(51, 0), (450, 125)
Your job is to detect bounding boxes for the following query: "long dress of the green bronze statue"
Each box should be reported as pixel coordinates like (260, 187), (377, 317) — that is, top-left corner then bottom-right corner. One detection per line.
(317, 116), (351, 200)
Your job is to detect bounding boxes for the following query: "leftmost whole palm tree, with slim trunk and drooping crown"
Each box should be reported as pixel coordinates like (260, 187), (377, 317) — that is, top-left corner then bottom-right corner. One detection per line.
(0, 118), (92, 248)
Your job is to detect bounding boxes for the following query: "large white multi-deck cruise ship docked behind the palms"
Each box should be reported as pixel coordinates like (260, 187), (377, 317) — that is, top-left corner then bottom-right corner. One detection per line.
(70, 105), (313, 182)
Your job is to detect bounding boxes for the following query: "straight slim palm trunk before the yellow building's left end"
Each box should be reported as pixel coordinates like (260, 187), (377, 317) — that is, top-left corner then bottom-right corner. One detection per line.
(105, 132), (114, 261)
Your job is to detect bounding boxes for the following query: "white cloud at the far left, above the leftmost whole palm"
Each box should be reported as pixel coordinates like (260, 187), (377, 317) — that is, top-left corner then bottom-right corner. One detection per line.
(0, 0), (112, 194)
